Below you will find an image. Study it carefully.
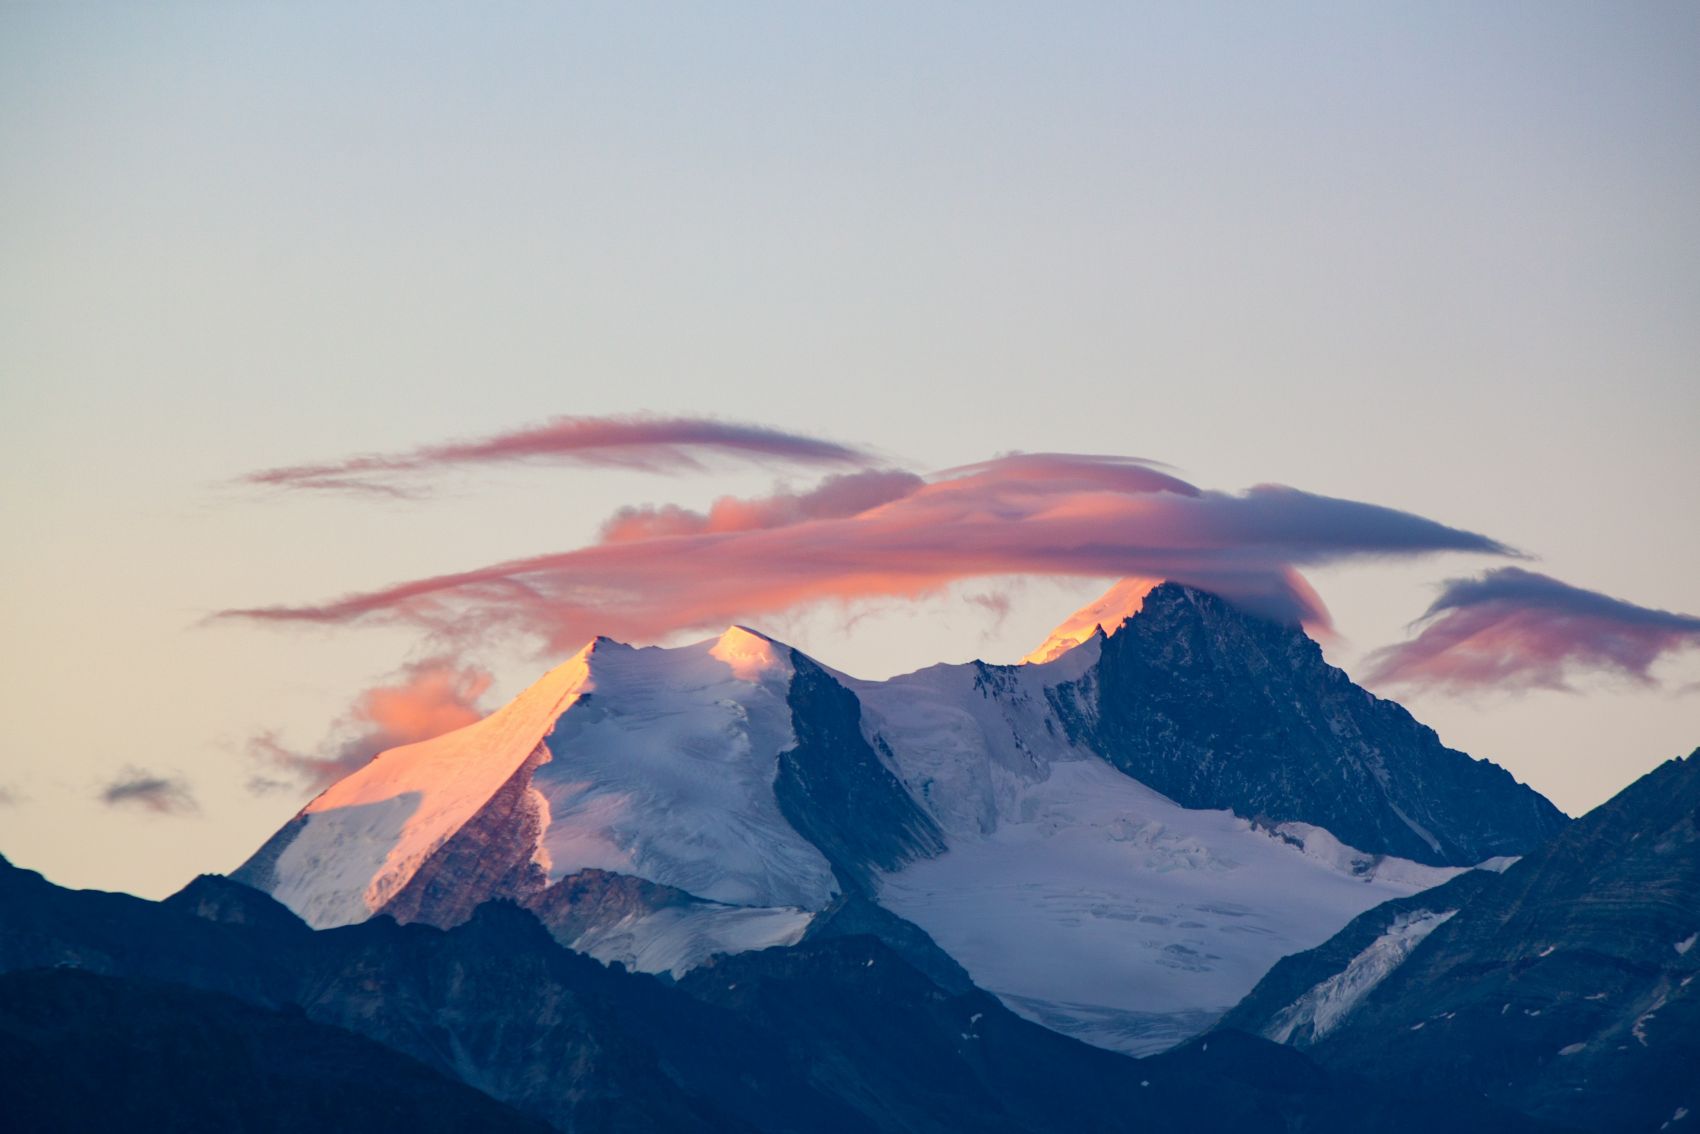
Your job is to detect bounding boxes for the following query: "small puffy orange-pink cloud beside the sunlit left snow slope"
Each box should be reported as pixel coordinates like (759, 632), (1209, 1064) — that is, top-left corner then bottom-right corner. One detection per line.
(248, 656), (490, 792)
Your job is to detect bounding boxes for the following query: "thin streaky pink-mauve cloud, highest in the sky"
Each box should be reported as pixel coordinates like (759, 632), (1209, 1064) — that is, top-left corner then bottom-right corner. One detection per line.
(241, 415), (879, 496)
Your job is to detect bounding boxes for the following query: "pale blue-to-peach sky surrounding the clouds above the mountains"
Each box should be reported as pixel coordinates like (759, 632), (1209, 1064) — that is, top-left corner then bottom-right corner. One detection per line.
(0, 3), (1700, 896)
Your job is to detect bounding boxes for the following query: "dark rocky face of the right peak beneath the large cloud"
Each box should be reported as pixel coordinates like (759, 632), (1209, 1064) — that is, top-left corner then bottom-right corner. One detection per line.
(1069, 583), (1566, 865)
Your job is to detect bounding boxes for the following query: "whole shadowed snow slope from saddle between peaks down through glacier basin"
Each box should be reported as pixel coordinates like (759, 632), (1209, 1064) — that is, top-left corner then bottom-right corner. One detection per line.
(859, 643), (1457, 1054)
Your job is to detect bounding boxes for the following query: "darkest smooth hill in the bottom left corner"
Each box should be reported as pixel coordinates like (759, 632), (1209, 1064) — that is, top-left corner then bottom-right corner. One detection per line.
(0, 969), (549, 1134)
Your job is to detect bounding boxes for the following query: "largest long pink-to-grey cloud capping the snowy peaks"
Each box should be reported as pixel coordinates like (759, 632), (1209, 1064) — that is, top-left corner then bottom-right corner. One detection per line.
(221, 454), (1515, 655)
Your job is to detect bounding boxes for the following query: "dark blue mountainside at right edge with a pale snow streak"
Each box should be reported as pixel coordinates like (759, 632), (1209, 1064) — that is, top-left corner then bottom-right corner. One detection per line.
(1224, 751), (1700, 1131)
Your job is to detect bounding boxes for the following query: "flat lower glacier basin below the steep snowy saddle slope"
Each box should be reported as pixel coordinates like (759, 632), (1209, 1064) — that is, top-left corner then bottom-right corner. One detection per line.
(879, 758), (1459, 1054)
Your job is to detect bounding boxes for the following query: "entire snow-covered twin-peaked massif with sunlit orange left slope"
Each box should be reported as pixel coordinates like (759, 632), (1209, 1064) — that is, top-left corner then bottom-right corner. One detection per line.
(235, 583), (1564, 1052)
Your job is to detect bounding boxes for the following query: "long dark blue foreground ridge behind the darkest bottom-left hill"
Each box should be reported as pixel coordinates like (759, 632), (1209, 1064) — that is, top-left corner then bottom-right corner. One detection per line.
(0, 859), (1549, 1134)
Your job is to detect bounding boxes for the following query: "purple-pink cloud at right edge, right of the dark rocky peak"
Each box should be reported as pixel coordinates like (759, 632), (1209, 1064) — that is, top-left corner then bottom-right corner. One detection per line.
(1369, 568), (1700, 692)
